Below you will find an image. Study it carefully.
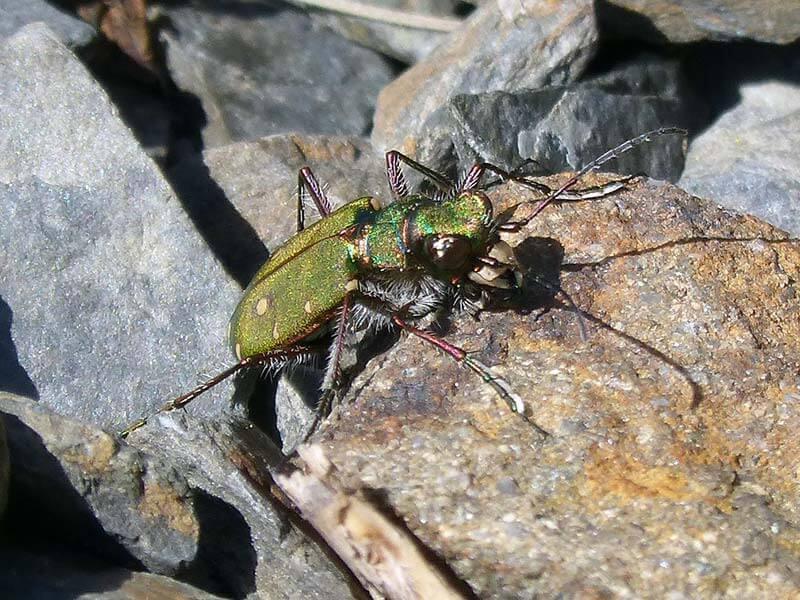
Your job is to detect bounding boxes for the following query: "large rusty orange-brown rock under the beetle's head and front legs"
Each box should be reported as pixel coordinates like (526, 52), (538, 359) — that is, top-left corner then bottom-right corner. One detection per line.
(310, 176), (800, 598)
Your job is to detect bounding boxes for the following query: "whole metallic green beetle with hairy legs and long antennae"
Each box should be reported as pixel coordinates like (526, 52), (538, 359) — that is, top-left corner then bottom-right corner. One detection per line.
(121, 127), (687, 436)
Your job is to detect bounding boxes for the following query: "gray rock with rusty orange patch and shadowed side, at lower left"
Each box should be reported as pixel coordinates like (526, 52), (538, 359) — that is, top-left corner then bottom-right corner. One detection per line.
(0, 393), (201, 575)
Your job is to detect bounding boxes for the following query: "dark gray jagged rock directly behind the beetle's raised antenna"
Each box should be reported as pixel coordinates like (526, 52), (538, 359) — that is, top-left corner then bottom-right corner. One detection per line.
(450, 60), (690, 181)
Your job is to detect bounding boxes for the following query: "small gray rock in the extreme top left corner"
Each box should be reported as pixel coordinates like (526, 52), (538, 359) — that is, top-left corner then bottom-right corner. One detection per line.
(0, 0), (95, 46)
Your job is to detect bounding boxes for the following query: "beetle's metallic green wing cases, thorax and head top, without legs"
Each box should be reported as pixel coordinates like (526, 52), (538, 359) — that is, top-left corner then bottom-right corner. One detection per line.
(230, 191), (492, 360)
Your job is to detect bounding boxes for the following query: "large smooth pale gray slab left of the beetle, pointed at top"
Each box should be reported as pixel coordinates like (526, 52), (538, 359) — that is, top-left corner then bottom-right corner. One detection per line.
(0, 26), (239, 426)
